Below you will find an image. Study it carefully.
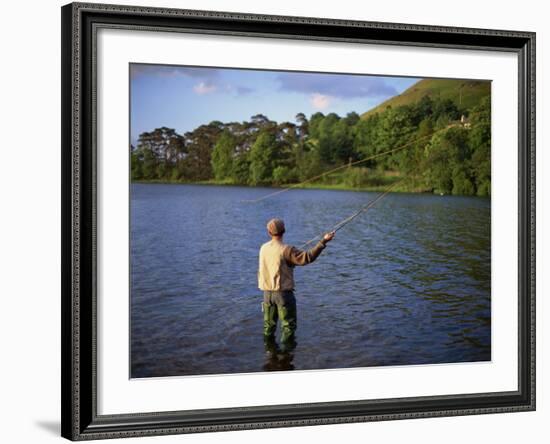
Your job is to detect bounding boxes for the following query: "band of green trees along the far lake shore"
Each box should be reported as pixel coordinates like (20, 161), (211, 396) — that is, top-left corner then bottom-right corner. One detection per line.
(131, 96), (491, 196)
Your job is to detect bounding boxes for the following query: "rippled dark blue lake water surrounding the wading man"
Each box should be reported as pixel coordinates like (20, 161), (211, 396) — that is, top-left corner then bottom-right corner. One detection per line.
(130, 184), (491, 378)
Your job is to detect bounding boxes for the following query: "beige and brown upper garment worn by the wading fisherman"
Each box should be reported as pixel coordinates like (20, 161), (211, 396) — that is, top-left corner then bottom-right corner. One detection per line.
(258, 239), (326, 290)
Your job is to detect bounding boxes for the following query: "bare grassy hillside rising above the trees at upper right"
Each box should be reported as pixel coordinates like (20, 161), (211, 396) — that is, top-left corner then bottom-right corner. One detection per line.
(361, 79), (491, 119)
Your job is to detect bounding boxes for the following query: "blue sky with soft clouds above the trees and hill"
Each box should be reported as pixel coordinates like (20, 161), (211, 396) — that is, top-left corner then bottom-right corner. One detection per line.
(130, 64), (419, 144)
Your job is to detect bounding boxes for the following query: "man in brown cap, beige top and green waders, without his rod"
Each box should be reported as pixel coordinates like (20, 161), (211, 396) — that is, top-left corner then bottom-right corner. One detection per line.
(258, 219), (334, 350)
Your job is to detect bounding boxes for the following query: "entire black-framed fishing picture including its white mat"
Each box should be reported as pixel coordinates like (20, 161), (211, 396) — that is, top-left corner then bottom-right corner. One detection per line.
(61, 3), (535, 440)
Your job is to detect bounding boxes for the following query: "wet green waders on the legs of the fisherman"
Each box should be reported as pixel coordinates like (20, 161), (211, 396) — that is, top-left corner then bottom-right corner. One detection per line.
(262, 290), (296, 347)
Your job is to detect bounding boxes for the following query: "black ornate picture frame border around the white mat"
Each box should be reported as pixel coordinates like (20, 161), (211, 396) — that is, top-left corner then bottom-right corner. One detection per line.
(61, 3), (535, 440)
